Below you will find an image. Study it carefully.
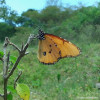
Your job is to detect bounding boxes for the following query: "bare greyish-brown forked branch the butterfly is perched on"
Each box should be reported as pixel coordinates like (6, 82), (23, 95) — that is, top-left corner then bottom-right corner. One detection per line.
(3, 35), (36, 100)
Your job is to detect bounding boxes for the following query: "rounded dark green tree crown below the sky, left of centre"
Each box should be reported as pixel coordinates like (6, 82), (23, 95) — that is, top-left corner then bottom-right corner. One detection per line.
(16, 9), (40, 27)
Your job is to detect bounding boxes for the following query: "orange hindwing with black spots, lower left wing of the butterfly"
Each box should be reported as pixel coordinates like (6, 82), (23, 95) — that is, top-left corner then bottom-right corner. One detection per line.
(38, 36), (61, 64)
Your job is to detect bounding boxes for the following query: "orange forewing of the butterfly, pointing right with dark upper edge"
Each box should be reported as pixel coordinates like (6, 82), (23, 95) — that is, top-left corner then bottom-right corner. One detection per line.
(45, 34), (80, 58)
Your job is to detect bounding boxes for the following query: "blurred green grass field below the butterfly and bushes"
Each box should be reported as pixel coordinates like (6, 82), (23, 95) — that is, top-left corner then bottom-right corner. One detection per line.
(0, 43), (100, 100)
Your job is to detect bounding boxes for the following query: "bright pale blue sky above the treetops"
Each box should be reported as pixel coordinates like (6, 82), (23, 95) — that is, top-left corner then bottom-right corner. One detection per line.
(6, 0), (100, 14)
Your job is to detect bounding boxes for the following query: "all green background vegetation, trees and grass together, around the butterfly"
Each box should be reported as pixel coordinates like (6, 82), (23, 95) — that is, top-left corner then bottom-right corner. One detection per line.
(0, 0), (100, 100)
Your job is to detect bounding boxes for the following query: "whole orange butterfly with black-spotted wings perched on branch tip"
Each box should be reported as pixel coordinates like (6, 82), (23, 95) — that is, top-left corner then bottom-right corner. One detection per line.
(38, 29), (80, 64)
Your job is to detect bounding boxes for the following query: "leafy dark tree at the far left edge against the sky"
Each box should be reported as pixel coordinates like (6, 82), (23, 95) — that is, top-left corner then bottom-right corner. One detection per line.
(0, 0), (17, 41)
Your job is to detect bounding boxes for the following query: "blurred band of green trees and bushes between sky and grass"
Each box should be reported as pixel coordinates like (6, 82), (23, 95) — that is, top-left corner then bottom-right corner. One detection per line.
(0, 3), (100, 42)
